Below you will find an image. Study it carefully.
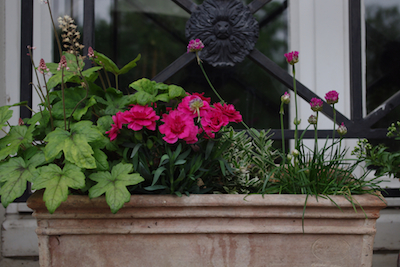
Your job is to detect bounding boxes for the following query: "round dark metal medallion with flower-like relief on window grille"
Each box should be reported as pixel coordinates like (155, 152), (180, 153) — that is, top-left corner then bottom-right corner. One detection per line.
(185, 0), (258, 67)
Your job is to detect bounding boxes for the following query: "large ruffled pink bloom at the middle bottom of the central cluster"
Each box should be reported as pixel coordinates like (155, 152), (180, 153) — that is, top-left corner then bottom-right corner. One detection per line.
(159, 110), (199, 144)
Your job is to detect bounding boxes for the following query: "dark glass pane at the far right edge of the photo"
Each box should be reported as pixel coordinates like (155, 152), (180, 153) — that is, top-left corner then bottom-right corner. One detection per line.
(365, 0), (400, 128)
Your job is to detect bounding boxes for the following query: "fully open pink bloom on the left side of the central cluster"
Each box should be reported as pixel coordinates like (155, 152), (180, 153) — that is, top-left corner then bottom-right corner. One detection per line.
(122, 105), (160, 131)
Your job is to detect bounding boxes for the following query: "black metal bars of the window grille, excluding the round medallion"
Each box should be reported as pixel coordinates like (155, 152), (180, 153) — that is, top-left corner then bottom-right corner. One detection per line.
(20, 0), (400, 200)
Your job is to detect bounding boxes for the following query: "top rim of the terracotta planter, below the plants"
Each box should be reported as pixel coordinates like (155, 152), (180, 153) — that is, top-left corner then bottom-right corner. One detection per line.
(27, 192), (386, 213)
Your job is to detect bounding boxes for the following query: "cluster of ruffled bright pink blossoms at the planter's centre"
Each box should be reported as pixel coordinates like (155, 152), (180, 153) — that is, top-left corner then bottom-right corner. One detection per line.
(106, 93), (242, 144)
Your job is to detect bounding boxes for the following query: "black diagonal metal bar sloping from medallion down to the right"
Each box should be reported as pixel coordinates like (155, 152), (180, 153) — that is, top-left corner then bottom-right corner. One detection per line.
(248, 49), (352, 128)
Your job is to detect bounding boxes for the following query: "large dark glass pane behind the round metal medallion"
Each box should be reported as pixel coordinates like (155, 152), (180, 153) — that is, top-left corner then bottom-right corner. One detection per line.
(56, 0), (287, 129)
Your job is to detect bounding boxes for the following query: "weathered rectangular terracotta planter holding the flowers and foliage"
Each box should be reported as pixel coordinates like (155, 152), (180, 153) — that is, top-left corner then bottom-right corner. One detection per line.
(28, 193), (386, 267)
